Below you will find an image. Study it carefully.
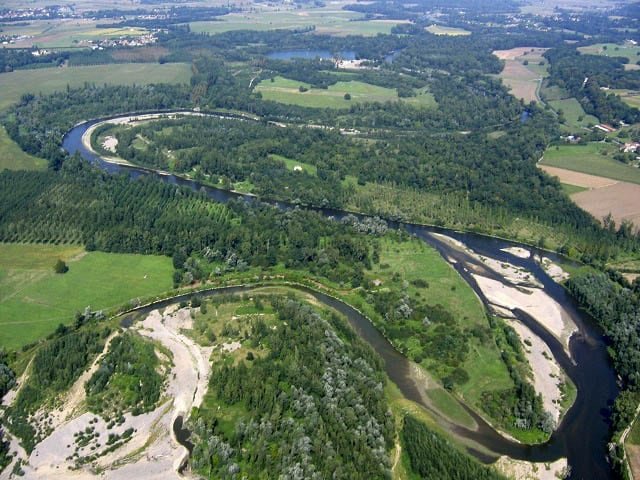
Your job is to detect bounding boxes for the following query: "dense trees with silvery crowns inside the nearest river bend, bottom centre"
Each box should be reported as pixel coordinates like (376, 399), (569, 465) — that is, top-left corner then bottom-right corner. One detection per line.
(192, 298), (394, 479)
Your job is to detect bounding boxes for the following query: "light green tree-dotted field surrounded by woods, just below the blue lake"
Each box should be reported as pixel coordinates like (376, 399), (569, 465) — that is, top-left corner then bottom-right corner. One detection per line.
(255, 77), (435, 108)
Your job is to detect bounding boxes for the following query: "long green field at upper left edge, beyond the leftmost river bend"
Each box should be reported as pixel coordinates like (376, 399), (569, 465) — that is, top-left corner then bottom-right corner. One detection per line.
(0, 63), (191, 110)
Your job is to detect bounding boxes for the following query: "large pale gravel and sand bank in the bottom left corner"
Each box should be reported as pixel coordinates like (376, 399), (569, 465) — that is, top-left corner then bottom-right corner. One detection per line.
(12, 308), (212, 480)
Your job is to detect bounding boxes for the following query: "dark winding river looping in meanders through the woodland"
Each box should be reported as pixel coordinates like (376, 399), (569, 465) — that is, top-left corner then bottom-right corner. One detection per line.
(63, 113), (617, 479)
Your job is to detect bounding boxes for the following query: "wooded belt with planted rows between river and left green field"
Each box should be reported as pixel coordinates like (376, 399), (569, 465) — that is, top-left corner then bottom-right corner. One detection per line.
(0, 159), (370, 285)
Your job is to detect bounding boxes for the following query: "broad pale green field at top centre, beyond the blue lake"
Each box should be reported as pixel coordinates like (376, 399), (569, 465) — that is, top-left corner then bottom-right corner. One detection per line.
(189, 7), (403, 36)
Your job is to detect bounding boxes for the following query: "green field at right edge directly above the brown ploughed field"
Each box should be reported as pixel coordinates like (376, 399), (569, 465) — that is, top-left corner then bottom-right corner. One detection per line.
(542, 143), (640, 183)
